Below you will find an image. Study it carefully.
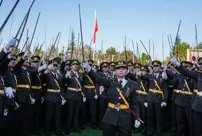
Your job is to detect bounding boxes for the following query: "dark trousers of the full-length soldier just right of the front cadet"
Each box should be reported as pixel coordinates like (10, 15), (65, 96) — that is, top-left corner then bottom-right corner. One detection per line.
(147, 102), (162, 136)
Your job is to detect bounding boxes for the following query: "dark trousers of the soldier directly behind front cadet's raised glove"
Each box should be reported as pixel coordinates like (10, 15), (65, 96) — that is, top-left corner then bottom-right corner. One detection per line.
(81, 99), (97, 125)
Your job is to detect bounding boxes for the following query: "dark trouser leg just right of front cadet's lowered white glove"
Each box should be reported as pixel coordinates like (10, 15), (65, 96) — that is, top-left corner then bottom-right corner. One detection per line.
(138, 101), (147, 133)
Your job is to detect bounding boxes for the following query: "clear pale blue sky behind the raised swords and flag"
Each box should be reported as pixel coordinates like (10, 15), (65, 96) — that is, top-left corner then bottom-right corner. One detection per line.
(0, 0), (202, 60)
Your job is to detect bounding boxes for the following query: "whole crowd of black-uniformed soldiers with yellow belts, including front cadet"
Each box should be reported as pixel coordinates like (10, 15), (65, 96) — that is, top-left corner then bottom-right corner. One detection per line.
(0, 39), (202, 136)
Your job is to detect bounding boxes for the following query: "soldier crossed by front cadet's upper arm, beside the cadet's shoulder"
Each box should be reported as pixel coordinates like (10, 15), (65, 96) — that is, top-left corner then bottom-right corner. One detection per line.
(98, 62), (110, 129)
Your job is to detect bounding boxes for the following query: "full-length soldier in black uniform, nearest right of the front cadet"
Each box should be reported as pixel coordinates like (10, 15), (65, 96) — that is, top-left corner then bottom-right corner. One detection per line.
(141, 60), (168, 136)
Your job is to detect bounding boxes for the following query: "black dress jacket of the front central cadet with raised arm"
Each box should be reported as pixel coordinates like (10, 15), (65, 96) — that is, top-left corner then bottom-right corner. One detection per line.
(88, 70), (140, 127)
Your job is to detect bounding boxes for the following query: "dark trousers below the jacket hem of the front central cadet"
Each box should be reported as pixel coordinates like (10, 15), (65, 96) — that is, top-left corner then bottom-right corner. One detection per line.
(103, 123), (132, 136)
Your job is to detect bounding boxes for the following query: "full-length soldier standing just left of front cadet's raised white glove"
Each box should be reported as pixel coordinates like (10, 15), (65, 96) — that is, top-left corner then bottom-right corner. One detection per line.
(64, 59), (86, 134)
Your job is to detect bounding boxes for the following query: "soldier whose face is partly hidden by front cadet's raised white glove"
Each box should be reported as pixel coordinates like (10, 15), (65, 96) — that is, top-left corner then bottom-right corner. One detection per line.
(81, 60), (98, 129)
